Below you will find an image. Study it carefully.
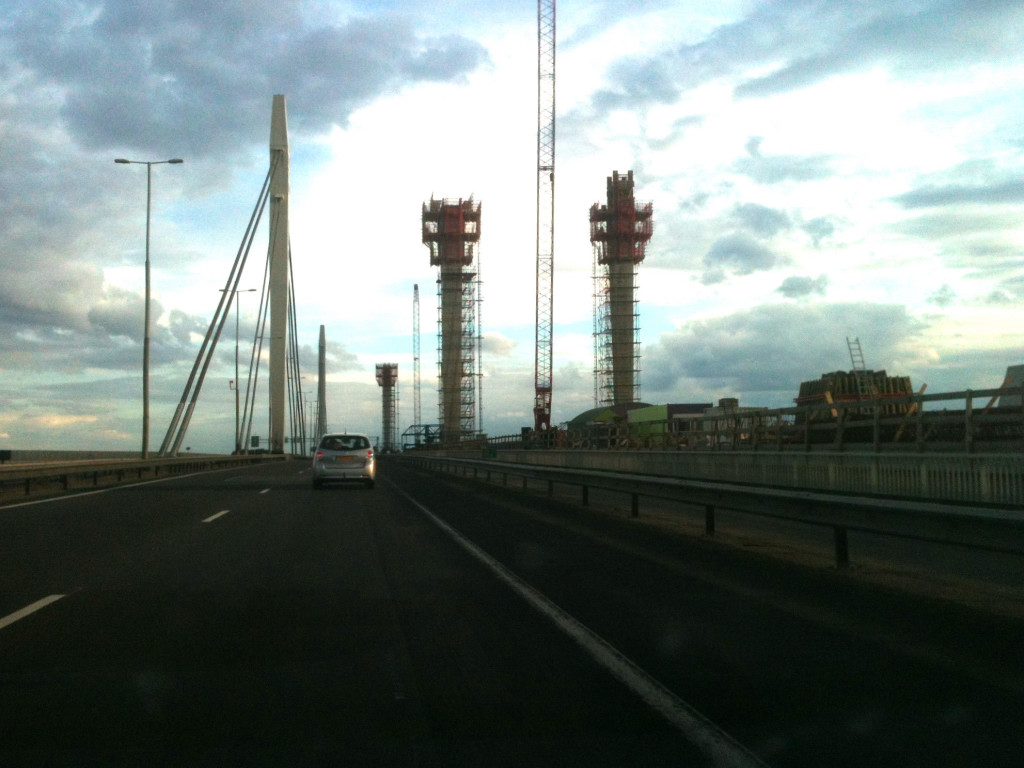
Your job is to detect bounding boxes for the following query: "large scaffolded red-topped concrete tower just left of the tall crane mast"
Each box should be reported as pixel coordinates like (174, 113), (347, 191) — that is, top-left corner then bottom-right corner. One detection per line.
(423, 198), (480, 442)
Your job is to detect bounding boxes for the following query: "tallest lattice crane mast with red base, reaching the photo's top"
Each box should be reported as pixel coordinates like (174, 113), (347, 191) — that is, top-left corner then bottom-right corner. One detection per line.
(534, 0), (555, 433)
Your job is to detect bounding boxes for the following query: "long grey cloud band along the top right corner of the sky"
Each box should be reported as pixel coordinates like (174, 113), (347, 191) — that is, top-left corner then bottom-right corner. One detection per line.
(592, 0), (1024, 113)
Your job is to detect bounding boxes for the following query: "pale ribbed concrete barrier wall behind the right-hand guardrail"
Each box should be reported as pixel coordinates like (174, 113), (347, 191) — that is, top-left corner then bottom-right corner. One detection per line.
(485, 450), (1024, 505)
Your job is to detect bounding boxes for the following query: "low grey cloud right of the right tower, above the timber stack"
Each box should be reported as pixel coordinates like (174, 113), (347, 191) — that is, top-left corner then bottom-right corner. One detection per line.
(644, 303), (924, 397)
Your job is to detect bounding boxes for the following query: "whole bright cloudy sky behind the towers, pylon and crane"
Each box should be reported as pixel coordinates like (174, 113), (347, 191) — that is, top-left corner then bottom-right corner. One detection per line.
(0, 0), (1024, 452)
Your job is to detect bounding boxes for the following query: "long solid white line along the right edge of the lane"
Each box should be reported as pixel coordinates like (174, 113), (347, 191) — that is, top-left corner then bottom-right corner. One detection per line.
(388, 481), (765, 768)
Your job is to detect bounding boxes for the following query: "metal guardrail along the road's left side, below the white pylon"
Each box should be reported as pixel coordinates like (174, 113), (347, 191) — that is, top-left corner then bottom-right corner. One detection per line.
(0, 454), (287, 502)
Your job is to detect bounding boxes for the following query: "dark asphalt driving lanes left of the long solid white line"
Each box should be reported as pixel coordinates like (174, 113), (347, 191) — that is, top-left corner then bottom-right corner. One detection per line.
(0, 462), (710, 766)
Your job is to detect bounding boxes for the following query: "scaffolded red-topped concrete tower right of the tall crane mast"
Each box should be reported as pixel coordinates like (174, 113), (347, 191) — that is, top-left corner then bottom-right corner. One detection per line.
(590, 171), (653, 406)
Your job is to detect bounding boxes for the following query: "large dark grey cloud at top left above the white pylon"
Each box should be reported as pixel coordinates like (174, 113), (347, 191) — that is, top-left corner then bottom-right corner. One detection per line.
(0, 0), (487, 157)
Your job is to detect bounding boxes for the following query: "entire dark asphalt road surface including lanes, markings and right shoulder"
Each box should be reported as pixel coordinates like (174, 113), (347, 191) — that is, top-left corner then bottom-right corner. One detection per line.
(0, 460), (1024, 768)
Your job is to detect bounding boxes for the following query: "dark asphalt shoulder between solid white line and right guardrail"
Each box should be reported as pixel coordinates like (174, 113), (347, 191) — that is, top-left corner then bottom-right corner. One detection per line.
(387, 460), (1024, 766)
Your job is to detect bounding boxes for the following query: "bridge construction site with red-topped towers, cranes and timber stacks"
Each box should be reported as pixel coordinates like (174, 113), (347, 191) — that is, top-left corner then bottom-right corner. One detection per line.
(378, 0), (1022, 450)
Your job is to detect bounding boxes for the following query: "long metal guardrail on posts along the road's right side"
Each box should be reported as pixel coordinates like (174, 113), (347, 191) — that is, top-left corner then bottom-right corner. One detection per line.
(402, 454), (1024, 568)
